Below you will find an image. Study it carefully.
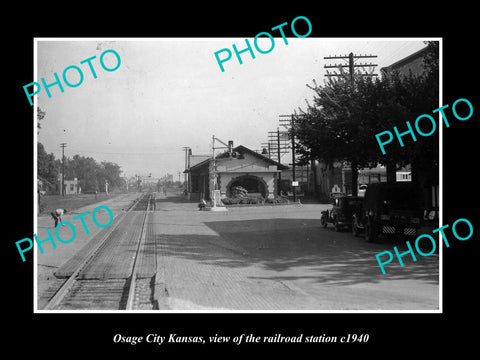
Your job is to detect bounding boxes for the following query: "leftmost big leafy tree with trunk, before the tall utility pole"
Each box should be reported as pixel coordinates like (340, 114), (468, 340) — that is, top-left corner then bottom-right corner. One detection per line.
(293, 76), (384, 195)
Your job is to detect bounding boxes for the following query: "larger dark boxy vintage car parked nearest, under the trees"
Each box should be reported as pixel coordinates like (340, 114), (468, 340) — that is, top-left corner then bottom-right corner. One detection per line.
(352, 182), (423, 242)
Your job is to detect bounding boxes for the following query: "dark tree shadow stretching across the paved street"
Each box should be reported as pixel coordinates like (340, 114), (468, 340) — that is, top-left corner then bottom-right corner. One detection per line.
(157, 218), (439, 285)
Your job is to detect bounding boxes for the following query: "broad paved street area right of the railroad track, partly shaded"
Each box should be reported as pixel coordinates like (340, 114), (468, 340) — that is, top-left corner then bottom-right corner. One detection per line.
(152, 197), (439, 310)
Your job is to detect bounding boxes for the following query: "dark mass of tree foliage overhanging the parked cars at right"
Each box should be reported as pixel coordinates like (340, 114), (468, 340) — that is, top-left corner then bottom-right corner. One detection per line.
(292, 42), (438, 186)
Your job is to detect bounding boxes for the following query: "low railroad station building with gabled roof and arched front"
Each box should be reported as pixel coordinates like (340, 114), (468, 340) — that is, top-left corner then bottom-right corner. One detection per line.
(185, 145), (288, 200)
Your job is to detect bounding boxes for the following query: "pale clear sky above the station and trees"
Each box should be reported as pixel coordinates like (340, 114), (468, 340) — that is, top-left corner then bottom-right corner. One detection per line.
(33, 37), (427, 179)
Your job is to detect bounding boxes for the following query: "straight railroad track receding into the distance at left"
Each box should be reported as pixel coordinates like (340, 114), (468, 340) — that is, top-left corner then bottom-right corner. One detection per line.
(44, 194), (156, 310)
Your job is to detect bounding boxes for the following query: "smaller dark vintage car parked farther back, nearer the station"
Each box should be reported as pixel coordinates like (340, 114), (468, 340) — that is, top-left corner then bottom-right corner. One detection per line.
(320, 195), (363, 231)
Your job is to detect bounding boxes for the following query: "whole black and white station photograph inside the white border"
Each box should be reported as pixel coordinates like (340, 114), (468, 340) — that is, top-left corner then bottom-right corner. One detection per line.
(32, 37), (438, 312)
